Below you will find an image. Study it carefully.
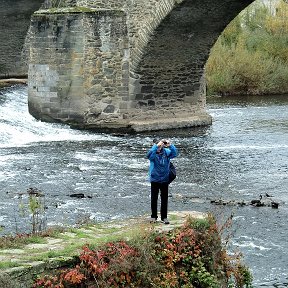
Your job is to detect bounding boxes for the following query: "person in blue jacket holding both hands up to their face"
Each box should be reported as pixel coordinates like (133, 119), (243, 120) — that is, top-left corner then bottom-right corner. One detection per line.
(147, 139), (178, 224)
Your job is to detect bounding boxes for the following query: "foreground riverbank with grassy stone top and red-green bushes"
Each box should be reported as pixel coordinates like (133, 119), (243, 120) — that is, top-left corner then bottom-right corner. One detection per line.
(0, 211), (251, 288)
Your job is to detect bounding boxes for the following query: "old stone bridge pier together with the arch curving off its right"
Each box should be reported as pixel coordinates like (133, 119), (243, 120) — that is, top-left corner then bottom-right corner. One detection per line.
(0, 0), (253, 132)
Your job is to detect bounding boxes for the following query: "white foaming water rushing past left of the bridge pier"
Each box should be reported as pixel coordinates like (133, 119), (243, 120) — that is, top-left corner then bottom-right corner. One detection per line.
(0, 86), (117, 148)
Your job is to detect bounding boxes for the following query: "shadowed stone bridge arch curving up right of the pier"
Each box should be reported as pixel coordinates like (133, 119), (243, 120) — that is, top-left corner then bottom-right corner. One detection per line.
(130, 0), (253, 122)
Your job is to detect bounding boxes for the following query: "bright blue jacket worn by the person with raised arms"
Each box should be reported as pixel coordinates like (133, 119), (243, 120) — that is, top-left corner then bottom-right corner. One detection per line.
(147, 144), (178, 183)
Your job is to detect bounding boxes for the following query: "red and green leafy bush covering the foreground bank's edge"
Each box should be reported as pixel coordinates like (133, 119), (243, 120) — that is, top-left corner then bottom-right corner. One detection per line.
(33, 216), (252, 288)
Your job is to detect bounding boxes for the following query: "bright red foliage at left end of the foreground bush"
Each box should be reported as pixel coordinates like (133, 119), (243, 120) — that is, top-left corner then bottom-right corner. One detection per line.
(33, 241), (138, 288)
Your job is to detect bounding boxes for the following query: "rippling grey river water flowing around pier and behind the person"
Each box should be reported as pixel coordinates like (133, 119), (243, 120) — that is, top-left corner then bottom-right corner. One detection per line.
(0, 86), (288, 288)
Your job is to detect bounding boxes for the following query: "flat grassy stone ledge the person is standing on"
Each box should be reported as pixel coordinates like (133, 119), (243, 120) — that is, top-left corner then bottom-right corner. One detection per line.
(0, 211), (207, 288)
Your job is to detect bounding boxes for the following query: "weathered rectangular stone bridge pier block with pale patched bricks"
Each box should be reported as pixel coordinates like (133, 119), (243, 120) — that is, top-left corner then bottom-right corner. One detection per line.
(28, 11), (128, 123)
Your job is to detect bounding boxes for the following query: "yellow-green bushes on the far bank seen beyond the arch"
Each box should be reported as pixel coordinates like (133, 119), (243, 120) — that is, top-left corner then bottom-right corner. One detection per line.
(206, 0), (288, 95)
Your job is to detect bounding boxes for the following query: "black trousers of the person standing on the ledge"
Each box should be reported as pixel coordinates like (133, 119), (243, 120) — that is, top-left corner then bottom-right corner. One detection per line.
(151, 182), (168, 220)
